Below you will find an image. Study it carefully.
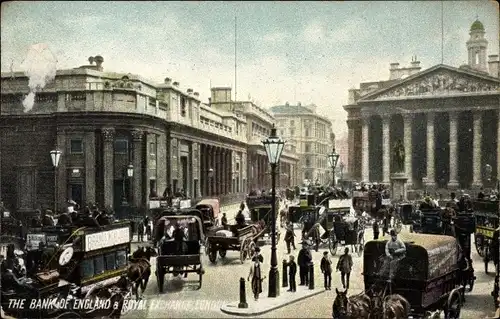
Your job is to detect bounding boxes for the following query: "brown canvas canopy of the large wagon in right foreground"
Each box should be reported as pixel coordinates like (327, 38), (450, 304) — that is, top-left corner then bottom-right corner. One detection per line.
(363, 233), (459, 281)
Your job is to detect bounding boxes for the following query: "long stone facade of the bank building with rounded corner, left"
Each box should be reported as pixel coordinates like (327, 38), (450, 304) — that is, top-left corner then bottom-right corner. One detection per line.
(0, 62), (297, 211)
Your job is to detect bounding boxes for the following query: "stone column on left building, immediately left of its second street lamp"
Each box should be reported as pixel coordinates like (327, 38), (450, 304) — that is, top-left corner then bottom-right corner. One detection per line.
(102, 128), (116, 208)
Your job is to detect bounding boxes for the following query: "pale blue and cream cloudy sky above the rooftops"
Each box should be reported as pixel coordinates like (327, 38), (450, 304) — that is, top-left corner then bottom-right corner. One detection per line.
(1, 0), (499, 137)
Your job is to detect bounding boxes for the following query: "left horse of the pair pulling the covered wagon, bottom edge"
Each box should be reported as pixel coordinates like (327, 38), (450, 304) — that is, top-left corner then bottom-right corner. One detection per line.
(332, 288), (372, 319)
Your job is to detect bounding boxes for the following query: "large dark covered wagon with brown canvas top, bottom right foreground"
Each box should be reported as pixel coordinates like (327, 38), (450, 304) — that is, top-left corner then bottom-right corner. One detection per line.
(363, 234), (468, 319)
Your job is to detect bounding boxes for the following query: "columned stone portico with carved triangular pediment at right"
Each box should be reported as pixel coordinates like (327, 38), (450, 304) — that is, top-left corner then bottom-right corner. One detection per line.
(344, 65), (500, 190)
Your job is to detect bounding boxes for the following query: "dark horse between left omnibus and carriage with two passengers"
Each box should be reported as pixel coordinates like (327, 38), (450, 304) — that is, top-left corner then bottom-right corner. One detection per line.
(127, 246), (158, 299)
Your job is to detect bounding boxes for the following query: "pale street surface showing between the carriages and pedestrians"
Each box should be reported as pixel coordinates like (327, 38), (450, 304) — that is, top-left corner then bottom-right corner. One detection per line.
(123, 205), (494, 319)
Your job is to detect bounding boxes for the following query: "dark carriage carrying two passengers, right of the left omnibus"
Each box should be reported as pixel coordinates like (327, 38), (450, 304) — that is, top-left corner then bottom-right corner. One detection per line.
(154, 209), (205, 293)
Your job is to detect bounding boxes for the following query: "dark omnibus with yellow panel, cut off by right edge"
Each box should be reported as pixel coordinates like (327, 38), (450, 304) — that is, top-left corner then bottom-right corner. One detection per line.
(473, 200), (500, 272)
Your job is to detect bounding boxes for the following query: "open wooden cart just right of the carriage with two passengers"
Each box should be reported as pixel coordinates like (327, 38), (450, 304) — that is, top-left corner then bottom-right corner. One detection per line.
(205, 222), (266, 264)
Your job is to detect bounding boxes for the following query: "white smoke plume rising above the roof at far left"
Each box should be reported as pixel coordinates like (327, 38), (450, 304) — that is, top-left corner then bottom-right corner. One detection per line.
(21, 43), (57, 113)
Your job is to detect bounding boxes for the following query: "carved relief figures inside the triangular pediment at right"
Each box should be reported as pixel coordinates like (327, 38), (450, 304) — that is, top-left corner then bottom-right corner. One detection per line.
(376, 72), (500, 99)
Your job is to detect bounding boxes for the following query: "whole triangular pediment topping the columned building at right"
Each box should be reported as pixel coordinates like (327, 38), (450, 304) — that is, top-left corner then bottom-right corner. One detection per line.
(359, 65), (500, 102)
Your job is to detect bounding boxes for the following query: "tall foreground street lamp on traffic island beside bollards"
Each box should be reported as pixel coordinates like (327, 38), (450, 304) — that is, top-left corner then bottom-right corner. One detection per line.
(262, 125), (285, 297)
